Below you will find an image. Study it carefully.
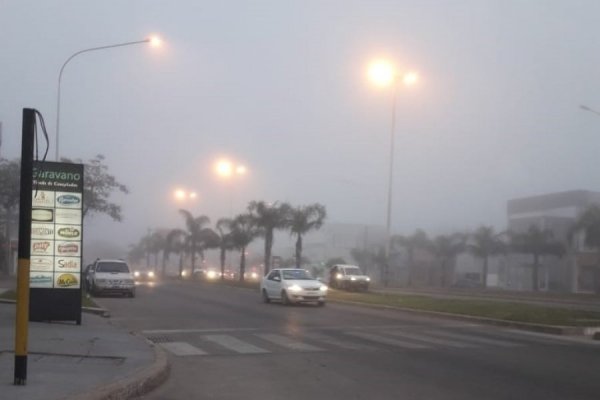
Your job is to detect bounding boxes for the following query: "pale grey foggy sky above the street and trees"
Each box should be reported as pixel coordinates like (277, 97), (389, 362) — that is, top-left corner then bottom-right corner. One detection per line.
(0, 0), (600, 256)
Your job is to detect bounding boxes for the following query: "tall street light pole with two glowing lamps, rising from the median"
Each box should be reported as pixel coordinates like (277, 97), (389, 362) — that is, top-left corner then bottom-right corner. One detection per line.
(368, 60), (417, 284)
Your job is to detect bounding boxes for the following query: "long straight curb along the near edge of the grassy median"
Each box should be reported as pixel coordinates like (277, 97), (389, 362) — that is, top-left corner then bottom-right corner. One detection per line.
(328, 299), (600, 340)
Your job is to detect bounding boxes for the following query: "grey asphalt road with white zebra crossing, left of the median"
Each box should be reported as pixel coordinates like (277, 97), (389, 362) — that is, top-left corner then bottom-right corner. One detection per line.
(94, 282), (600, 400)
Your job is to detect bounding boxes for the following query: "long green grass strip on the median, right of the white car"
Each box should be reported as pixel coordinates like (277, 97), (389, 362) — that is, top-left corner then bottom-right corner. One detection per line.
(328, 290), (600, 326)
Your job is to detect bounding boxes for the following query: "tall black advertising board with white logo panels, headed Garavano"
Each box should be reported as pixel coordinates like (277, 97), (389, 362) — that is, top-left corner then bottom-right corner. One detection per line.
(29, 161), (83, 323)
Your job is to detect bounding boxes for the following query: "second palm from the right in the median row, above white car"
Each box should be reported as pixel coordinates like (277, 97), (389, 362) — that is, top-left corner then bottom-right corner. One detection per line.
(248, 201), (292, 274)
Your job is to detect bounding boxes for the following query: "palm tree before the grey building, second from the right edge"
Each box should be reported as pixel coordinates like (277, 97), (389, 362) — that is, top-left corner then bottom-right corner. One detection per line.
(510, 225), (565, 292)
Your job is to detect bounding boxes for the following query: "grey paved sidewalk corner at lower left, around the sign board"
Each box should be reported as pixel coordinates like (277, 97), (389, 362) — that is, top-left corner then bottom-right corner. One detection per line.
(0, 280), (169, 400)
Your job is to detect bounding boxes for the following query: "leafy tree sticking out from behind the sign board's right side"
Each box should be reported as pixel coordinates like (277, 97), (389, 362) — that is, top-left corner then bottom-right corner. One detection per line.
(61, 154), (129, 222)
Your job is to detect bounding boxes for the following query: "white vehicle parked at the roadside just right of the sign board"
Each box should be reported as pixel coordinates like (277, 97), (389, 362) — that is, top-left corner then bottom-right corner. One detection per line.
(87, 259), (135, 297)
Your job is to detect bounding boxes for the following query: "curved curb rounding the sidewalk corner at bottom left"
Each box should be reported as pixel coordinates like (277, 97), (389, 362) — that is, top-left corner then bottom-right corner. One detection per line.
(65, 333), (171, 400)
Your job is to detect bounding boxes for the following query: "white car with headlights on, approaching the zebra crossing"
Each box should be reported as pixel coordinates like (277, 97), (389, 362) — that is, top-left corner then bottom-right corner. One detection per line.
(260, 268), (327, 306)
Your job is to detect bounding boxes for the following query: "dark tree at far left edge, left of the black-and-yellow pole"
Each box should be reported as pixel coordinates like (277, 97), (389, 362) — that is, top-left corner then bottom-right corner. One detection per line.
(0, 159), (21, 275)
